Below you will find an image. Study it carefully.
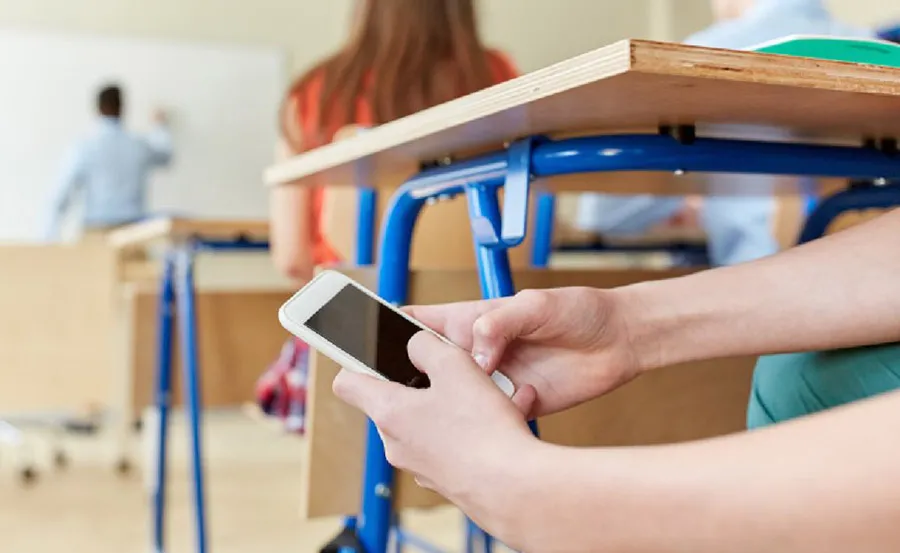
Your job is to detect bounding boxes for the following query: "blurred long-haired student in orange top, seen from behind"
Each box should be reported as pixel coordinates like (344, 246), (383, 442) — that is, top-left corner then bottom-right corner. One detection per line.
(258, 0), (516, 431)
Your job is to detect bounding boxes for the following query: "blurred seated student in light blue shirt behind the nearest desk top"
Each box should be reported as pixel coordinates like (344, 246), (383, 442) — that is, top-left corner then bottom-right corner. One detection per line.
(576, 0), (874, 265)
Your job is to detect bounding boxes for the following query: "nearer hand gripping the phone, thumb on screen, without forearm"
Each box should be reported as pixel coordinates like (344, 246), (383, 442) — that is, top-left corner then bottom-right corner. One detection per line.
(334, 332), (544, 525)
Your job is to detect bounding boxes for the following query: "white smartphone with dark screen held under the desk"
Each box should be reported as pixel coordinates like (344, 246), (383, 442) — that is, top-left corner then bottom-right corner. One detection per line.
(278, 271), (515, 397)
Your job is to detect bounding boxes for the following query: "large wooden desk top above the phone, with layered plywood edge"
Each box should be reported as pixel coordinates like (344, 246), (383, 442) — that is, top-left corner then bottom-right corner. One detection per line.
(265, 40), (900, 192)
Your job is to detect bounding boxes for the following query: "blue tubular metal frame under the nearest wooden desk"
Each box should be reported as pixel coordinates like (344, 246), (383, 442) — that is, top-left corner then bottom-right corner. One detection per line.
(341, 130), (900, 553)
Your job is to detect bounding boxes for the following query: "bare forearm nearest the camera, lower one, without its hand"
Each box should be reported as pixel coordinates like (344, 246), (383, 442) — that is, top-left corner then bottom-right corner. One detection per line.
(510, 388), (900, 553)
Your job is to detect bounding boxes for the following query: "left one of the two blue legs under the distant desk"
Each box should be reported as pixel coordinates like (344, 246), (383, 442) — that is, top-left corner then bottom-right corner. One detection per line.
(152, 254), (175, 553)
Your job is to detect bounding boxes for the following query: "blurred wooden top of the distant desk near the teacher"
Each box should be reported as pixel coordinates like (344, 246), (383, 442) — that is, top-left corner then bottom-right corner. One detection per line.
(109, 218), (269, 249)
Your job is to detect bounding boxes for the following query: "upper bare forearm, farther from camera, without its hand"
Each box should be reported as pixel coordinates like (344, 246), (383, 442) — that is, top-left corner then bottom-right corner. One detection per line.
(616, 211), (900, 368)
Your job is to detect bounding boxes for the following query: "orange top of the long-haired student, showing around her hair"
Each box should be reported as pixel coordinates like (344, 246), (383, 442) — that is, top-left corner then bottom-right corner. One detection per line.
(289, 50), (518, 265)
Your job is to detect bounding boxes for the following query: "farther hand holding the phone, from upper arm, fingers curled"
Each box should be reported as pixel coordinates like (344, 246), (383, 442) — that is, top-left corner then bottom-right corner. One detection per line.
(406, 288), (641, 417)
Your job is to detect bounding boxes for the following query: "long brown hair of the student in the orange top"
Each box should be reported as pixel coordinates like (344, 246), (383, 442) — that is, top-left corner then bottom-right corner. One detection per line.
(282, 0), (493, 151)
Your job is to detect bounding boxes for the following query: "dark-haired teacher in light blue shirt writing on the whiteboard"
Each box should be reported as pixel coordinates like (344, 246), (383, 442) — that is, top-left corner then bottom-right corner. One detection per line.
(47, 86), (172, 241)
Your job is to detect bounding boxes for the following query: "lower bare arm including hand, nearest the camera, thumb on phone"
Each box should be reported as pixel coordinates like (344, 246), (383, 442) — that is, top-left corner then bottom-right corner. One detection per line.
(334, 333), (900, 553)
